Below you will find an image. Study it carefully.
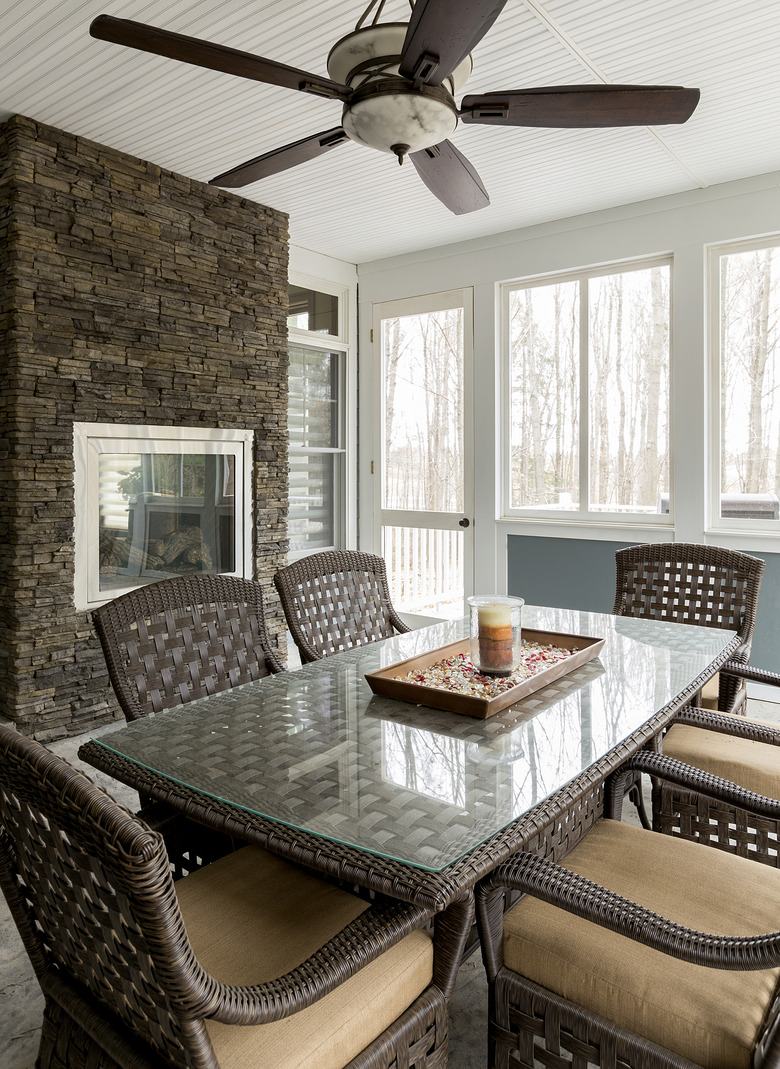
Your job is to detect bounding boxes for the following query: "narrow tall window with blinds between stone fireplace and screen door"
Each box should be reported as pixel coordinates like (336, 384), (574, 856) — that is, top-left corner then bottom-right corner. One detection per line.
(287, 283), (347, 558)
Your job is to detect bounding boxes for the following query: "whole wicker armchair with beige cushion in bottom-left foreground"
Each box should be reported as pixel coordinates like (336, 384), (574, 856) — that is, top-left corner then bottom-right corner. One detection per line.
(0, 726), (448, 1069)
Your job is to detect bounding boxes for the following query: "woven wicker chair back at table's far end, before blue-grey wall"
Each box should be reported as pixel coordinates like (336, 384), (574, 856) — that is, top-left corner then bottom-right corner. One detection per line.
(612, 542), (765, 661)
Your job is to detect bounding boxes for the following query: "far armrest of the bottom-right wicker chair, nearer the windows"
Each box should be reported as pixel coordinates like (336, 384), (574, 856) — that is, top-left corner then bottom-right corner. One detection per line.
(605, 749), (780, 820)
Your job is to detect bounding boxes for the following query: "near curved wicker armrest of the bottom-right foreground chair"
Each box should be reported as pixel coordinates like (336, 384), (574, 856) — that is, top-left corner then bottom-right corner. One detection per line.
(478, 846), (780, 971)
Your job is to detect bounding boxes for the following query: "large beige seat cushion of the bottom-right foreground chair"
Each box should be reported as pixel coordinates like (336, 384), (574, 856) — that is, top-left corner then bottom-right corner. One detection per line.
(497, 820), (780, 1069)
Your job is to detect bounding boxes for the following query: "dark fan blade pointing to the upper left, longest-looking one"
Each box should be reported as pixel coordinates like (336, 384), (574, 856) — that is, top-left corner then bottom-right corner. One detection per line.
(90, 15), (350, 99)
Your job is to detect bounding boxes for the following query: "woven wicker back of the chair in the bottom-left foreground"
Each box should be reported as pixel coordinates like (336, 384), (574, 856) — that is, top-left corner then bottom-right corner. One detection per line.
(0, 727), (208, 1067)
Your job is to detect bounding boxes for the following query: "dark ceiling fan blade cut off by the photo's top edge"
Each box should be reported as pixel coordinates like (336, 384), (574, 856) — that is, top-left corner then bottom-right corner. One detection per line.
(399, 0), (506, 86)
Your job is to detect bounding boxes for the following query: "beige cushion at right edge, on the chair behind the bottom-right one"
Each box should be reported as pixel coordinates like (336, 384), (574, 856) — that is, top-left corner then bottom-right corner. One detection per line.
(662, 716), (780, 799)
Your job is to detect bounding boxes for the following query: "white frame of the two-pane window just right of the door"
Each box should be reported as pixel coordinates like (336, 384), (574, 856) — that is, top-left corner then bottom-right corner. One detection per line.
(498, 253), (674, 528)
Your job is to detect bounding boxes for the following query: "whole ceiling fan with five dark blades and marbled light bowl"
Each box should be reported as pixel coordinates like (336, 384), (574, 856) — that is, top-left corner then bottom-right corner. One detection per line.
(90, 0), (699, 215)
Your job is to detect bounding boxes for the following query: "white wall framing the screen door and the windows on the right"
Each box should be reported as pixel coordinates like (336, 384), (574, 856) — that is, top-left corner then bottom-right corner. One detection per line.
(358, 164), (780, 590)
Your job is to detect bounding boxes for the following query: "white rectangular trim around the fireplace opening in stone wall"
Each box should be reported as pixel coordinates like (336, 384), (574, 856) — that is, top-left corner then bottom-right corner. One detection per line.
(74, 423), (254, 611)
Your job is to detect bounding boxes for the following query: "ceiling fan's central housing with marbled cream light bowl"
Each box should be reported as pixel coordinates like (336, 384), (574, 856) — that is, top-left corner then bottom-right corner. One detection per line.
(328, 22), (472, 157)
